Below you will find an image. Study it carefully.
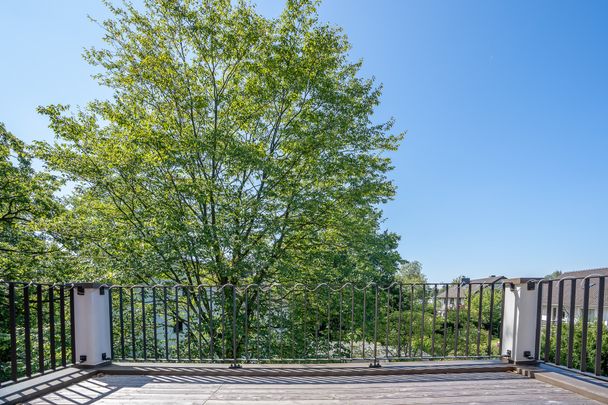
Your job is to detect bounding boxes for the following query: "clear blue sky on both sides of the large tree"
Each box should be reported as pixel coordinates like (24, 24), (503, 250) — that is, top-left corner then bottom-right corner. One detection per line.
(0, 0), (608, 281)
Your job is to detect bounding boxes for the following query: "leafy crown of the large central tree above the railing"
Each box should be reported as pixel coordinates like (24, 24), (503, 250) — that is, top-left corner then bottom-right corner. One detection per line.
(38, 0), (402, 284)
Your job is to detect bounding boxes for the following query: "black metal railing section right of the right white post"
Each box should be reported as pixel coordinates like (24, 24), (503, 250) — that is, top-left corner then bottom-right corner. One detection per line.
(536, 274), (608, 376)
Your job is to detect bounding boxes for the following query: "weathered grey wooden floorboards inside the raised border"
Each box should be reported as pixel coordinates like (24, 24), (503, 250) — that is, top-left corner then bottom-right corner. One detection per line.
(28, 372), (598, 405)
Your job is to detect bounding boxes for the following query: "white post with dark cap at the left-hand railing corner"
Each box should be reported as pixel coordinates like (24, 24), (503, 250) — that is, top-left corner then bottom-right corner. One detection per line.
(74, 283), (112, 367)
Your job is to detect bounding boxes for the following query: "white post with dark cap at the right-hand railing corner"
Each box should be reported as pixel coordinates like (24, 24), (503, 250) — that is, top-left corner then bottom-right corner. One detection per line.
(501, 278), (540, 364)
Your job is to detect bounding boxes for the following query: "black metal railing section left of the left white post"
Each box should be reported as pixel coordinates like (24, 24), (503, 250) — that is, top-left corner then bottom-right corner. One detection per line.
(0, 281), (74, 386)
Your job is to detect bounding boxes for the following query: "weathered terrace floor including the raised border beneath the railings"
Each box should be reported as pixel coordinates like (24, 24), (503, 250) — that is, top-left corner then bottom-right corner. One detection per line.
(0, 360), (608, 405)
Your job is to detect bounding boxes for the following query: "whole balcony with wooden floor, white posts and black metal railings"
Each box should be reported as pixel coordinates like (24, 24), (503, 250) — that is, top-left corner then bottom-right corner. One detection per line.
(0, 276), (608, 404)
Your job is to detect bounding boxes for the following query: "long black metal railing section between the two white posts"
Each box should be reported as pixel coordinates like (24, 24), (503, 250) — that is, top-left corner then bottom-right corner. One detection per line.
(104, 282), (504, 366)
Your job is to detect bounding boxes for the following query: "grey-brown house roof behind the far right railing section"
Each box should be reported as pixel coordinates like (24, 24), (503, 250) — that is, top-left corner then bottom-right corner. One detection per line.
(542, 267), (608, 309)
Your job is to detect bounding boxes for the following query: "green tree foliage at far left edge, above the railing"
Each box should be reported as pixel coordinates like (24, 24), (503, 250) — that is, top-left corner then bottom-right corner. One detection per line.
(0, 123), (73, 281)
